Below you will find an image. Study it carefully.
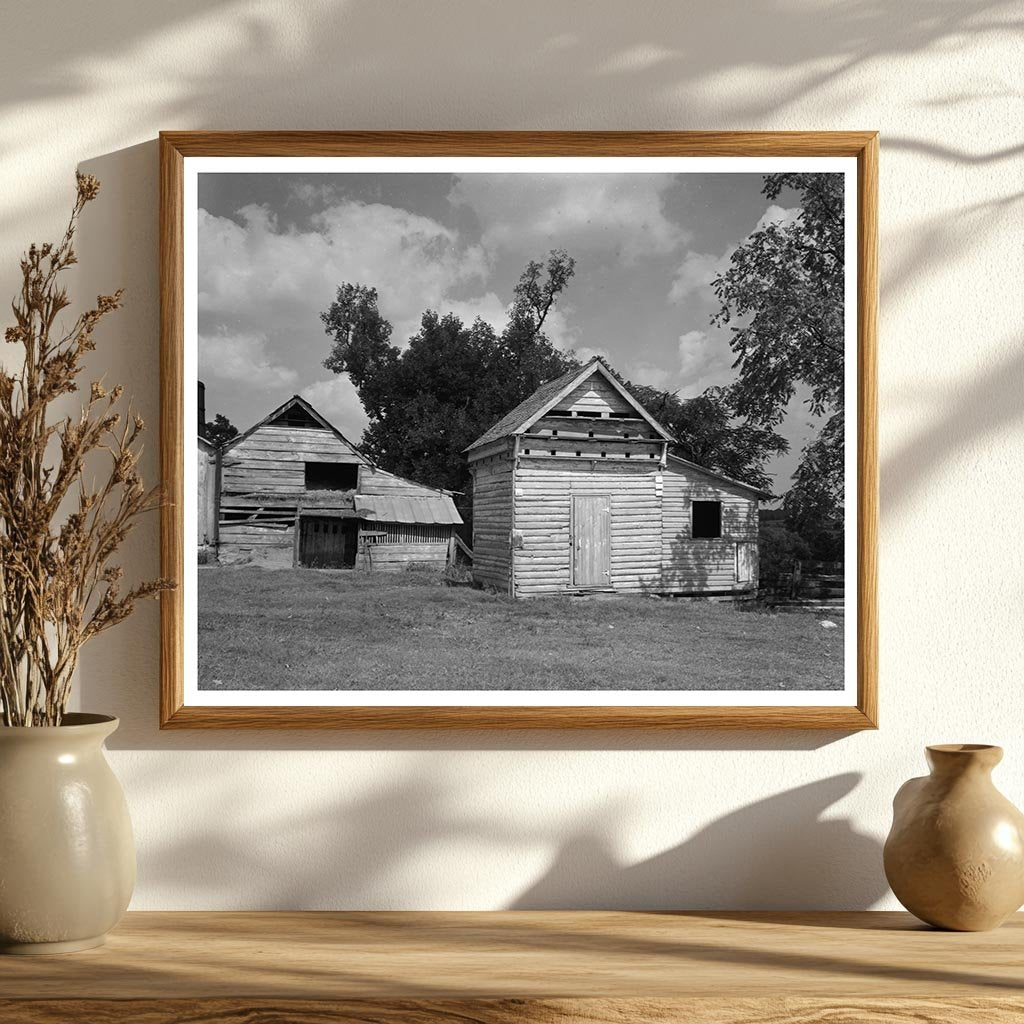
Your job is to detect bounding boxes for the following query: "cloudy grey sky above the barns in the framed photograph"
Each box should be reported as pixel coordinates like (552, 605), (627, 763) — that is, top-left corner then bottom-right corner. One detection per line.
(198, 173), (835, 490)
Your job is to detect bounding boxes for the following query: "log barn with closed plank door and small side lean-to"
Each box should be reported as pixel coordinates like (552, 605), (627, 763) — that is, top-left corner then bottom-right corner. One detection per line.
(467, 357), (769, 597)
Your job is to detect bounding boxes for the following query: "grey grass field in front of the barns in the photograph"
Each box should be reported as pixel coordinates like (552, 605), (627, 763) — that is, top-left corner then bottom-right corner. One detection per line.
(199, 566), (843, 690)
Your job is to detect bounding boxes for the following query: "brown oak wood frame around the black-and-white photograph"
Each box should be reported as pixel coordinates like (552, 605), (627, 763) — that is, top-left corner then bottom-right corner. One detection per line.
(160, 131), (879, 730)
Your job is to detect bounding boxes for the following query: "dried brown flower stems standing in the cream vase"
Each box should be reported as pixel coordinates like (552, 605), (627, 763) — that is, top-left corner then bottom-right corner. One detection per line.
(0, 173), (172, 726)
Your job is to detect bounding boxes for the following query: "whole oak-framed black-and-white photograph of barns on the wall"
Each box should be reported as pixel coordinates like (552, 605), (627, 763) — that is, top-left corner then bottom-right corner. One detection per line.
(160, 132), (878, 730)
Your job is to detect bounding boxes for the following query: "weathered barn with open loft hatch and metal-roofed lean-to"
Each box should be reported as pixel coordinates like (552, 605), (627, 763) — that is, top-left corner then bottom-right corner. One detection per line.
(216, 395), (462, 571)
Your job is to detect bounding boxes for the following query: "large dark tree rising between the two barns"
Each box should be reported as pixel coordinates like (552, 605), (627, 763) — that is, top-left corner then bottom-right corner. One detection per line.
(321, 250), (579, 508)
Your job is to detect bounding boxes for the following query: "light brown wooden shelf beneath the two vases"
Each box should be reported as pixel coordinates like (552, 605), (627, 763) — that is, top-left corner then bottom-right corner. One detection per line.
(0, 911), (1024, 1024)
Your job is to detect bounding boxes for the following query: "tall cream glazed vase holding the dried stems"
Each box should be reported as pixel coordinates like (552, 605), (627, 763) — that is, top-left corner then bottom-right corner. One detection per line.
(0, 714), (135, 953)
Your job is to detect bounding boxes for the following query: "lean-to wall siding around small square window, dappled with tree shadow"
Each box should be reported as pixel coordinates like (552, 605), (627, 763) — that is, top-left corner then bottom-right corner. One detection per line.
(663, 459), (758, 593)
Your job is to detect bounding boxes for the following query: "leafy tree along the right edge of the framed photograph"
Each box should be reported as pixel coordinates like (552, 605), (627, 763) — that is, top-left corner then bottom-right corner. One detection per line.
(712, 174), (845, 524)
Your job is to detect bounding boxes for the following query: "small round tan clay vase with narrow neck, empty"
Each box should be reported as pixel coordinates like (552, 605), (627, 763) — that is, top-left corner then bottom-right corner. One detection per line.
(885, 743), (1024, 932)
